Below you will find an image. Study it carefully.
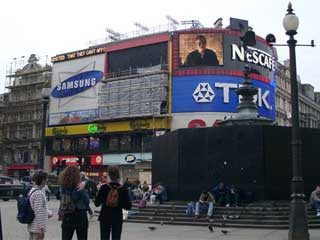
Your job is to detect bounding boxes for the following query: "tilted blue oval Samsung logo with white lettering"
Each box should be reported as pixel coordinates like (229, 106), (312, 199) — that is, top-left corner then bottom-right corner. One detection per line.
(51, 70), (103, 98)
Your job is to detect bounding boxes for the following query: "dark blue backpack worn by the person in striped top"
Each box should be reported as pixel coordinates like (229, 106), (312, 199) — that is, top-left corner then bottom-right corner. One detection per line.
(17, 189), (40, 224)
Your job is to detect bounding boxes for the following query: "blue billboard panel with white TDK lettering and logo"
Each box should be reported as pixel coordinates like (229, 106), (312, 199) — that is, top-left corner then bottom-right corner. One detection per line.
(172, 75), (275, 120)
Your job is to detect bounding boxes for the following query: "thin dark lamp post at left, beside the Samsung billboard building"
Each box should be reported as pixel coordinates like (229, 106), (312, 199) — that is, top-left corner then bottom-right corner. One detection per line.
(38, 88), (50, 169)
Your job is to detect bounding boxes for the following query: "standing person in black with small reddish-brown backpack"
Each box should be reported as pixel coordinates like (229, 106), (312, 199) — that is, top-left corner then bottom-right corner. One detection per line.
(94, 166), (132, 240)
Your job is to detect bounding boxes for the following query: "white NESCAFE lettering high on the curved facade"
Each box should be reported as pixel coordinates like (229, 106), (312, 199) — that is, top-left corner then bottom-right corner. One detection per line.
(231, 44), (276, 71)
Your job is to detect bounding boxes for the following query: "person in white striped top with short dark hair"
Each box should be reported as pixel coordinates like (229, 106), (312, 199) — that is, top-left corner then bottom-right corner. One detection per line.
(28, 170), (52, 240)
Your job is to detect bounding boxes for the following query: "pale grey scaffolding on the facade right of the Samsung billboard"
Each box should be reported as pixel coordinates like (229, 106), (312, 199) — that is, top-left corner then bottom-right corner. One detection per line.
(98, 65), (168, 120)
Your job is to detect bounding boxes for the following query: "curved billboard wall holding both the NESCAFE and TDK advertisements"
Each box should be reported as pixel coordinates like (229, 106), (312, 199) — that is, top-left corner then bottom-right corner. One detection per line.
(172, 29), (276, 121)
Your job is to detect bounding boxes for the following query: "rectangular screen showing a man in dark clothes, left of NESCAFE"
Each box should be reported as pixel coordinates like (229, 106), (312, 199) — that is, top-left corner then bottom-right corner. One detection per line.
(179, 33), (223, 67)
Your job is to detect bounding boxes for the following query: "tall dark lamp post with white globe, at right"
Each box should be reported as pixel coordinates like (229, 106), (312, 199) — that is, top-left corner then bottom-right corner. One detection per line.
(283, 3), (309, 240)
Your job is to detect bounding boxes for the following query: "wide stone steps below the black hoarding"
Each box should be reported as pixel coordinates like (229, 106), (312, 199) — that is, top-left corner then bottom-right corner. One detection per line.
(127, 203), (320, 229)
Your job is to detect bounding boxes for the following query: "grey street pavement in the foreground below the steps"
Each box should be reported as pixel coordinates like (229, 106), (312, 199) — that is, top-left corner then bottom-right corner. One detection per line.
(0, 200), (320, 240)
